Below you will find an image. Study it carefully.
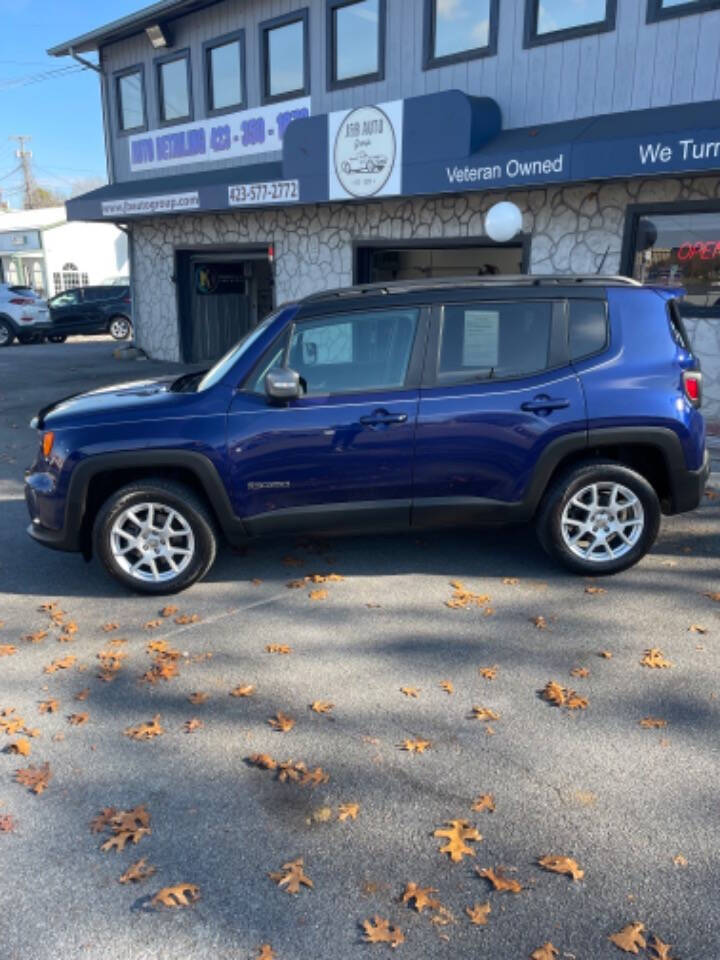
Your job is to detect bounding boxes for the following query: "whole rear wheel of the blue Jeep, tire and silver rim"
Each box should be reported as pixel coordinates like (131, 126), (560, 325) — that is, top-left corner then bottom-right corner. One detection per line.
(537, 463), (660, 576)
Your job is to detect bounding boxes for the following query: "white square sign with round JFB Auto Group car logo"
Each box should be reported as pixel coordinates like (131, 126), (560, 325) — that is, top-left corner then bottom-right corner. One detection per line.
(328, 100), (403, 200)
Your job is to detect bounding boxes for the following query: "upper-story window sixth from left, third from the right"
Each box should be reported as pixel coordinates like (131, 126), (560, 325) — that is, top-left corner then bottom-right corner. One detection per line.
(425, 0), (500, 69)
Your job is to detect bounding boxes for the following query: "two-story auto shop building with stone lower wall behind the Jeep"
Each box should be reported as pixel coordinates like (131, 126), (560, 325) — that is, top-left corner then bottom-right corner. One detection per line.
(50, 0), (720, 417)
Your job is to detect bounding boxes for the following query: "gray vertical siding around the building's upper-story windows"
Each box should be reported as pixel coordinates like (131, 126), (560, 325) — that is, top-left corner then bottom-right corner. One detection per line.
(102, 0), (720, 180)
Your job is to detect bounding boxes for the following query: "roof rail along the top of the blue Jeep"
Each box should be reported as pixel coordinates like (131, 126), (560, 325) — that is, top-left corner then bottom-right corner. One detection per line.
(303, 274), (642, 303)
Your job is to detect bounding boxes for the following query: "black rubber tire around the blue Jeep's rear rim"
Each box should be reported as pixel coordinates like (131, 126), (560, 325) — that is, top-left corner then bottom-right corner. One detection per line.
(536, 461), (661, 576)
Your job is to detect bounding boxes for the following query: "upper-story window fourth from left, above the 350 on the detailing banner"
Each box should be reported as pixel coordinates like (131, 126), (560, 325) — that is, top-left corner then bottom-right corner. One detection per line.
(260, 8), (310, 103)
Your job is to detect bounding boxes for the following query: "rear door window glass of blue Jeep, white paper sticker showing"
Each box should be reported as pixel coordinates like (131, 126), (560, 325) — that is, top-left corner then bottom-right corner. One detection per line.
(437, 300), (553, 383)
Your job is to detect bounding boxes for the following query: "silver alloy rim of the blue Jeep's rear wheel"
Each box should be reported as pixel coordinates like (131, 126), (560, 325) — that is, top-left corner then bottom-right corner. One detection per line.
(561, 481), (645, 564)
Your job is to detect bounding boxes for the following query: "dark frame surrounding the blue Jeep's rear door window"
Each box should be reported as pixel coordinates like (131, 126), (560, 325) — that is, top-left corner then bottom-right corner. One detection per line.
(422, 294), (570, 390)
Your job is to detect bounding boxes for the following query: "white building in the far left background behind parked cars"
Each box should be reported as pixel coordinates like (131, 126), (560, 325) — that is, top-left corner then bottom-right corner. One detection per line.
(0, 207), (130, 297)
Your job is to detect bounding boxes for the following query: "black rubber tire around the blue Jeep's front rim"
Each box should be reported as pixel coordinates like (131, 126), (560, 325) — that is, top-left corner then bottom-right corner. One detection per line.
(93, 477), (217, 595)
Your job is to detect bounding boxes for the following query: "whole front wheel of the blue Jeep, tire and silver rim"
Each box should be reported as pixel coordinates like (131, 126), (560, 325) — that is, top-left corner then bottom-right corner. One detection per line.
(94, 478), (217, 594)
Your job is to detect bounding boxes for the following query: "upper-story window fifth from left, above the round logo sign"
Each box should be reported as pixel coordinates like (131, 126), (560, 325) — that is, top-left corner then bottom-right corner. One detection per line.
(327, 0), (385, 90)
